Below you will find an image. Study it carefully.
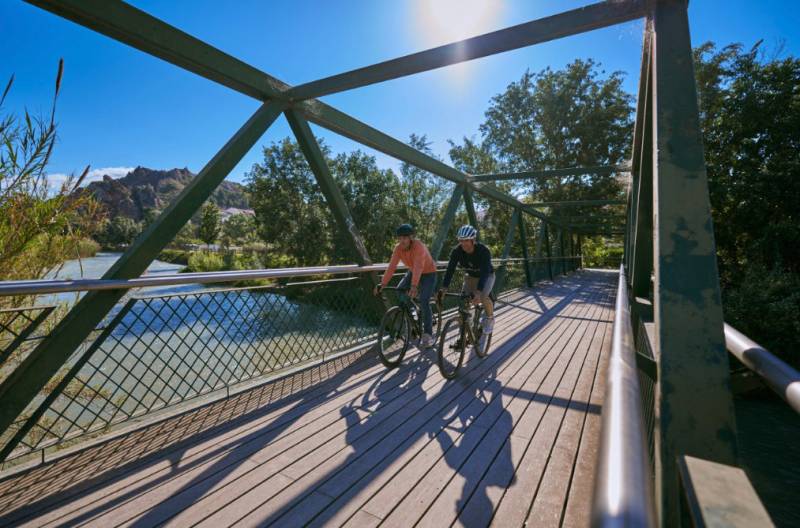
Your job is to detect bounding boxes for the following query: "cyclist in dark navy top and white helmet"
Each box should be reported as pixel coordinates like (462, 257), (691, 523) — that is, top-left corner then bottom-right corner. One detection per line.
(439, 225), (494, 334)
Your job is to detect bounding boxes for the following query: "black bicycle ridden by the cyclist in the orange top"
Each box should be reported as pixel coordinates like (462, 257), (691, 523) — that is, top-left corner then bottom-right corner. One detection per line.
(377, 286), (442, 369)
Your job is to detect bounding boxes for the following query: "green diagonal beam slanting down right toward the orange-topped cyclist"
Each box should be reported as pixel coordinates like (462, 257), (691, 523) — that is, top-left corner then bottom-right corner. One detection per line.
(285, 110), (372, 266)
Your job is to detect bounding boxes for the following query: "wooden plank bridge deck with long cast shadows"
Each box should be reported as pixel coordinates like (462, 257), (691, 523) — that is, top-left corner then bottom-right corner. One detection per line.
(0, 271), (616, 527)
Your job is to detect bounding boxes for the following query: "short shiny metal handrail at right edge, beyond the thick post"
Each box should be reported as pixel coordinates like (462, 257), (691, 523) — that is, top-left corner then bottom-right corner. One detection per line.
(725, 323), (800, 413)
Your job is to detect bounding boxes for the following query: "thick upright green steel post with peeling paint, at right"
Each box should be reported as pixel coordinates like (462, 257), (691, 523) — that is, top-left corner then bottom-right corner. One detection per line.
(652, 0), (737, 526)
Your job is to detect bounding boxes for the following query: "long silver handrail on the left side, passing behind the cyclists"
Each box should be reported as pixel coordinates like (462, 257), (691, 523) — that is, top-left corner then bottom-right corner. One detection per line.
(0, 257), (580, 297)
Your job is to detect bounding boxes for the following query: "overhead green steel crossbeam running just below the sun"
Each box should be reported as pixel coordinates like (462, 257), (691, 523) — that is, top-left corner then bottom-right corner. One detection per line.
(289, 0), (645, 100)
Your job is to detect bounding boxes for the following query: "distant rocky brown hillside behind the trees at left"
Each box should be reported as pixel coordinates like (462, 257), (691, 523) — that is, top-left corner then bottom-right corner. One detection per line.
(86, 167), (249, 221)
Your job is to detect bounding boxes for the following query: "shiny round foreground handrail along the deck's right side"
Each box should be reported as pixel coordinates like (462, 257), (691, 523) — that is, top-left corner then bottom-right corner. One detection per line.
(592, 267), (656, 527)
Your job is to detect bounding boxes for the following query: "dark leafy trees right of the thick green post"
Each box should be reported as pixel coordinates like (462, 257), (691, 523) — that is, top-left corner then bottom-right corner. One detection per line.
(695, 43), (800, 364)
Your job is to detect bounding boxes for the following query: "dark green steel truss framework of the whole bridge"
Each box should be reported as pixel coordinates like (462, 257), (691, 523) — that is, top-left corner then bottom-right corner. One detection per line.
(0, 0), (736, 526)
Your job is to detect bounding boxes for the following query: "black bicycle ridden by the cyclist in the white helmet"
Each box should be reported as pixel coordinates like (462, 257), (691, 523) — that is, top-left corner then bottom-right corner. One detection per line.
(438, 293), (492, 379)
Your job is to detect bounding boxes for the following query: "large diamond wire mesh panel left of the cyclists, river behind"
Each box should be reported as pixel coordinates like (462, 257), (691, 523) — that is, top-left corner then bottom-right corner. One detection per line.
(12, 278), (377, 456)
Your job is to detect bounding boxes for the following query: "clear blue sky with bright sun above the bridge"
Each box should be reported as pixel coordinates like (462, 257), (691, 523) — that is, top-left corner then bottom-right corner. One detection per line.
(0, 0), (800, 188)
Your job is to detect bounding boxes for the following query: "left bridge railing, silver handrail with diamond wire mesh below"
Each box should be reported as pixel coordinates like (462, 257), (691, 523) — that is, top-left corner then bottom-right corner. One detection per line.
(0, 257), (580, 462)
